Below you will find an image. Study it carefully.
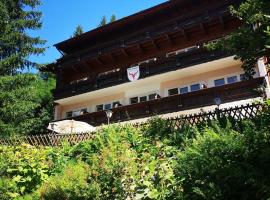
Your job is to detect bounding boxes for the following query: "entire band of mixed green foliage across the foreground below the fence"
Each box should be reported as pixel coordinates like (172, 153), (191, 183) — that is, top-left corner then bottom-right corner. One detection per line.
(0, 104), (270, 200)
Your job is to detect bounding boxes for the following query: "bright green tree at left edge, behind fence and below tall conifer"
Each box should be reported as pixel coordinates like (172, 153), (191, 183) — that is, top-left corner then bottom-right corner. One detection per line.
(0, 74), (55, 137)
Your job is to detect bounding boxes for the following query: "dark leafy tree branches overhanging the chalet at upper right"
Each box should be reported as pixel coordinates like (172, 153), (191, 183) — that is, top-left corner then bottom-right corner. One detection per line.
(207, 0), (270, 78)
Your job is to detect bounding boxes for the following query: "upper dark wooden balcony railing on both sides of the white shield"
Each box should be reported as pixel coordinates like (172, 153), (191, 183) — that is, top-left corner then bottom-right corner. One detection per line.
(54, 49), (228, 99)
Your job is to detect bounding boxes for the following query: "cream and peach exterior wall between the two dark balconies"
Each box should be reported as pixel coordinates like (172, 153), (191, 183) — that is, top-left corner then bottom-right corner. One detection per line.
(55, 57), (258, 120)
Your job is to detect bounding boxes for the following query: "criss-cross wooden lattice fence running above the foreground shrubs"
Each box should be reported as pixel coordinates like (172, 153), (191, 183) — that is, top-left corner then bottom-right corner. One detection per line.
(0, 104), (264, 146)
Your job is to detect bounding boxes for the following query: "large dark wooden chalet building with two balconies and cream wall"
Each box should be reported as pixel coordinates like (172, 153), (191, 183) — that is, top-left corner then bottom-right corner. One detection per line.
(47, 0), (269, 126)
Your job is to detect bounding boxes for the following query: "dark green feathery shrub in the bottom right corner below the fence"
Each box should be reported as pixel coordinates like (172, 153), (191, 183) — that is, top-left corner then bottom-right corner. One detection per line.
(176, 124), (270, 199)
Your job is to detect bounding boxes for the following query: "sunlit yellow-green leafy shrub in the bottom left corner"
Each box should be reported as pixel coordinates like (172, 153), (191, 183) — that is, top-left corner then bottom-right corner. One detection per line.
(0, 144), (52, 199)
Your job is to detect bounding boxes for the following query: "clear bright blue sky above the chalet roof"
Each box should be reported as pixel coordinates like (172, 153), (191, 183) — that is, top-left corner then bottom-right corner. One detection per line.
(31, 0), (166, 63)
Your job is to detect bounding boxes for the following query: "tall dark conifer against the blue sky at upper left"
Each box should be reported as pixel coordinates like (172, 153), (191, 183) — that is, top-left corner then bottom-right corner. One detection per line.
(0, 0), (45, 75)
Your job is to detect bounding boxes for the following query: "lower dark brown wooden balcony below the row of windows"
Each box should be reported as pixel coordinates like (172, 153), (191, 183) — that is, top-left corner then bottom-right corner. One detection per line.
(68, 78), (264, 126)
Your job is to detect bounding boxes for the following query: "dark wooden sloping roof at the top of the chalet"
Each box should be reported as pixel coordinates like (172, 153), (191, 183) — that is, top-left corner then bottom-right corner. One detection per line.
(55, 0), (240, 54)
